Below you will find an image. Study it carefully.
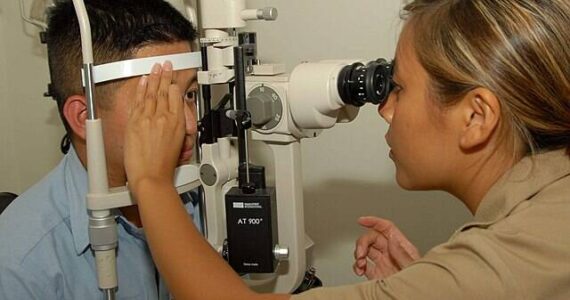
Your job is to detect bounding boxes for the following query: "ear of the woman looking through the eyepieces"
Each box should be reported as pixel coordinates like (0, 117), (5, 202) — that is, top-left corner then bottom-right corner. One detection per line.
(459, 88), (501, 151)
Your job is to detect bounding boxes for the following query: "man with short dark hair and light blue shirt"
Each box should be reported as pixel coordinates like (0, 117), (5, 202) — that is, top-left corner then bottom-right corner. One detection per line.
(0, 0), (198, 299)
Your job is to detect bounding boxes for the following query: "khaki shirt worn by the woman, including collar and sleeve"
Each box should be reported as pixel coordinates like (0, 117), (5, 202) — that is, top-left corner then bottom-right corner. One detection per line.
(291, 150), (570, 300)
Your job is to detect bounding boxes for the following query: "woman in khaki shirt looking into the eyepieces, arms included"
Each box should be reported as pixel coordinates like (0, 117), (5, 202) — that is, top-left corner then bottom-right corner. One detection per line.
(125, 0), (570, 300)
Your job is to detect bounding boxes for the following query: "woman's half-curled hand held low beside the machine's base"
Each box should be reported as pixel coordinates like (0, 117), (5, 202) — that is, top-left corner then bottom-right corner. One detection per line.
(353, 217), (420, 279)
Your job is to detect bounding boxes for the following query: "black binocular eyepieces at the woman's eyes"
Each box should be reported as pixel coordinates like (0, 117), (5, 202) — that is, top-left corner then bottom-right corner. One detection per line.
(338, 58), (394, 107)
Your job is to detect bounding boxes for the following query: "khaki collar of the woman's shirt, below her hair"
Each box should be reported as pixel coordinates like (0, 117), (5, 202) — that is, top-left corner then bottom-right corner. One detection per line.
(471, 150), (570, 225)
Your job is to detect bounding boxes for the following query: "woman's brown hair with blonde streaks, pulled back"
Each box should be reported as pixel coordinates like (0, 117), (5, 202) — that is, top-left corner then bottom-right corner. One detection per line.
(404, 0), (570, 155)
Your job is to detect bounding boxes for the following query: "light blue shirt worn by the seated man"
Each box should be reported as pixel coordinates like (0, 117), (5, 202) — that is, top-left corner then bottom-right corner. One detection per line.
(0, 148), (200, 300)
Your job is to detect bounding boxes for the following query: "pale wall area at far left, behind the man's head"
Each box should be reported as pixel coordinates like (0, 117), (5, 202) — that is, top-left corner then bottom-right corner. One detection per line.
(0, 1), (63, 193)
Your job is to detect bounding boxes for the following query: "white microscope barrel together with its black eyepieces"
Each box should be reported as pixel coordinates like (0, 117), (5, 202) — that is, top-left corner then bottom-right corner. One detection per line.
(276, 59), (394, 129)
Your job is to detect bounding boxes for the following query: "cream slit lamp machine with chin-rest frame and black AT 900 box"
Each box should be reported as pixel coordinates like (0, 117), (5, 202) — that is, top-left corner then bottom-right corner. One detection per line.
(21, 0), (393, 299)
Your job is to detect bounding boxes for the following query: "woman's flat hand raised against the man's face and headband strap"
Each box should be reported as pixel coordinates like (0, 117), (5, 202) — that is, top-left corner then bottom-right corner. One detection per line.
(124, 62), (185, 194)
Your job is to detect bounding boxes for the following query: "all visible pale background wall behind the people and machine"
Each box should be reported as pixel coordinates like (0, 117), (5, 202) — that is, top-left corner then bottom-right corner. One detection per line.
(0, 0), (469, 285)
